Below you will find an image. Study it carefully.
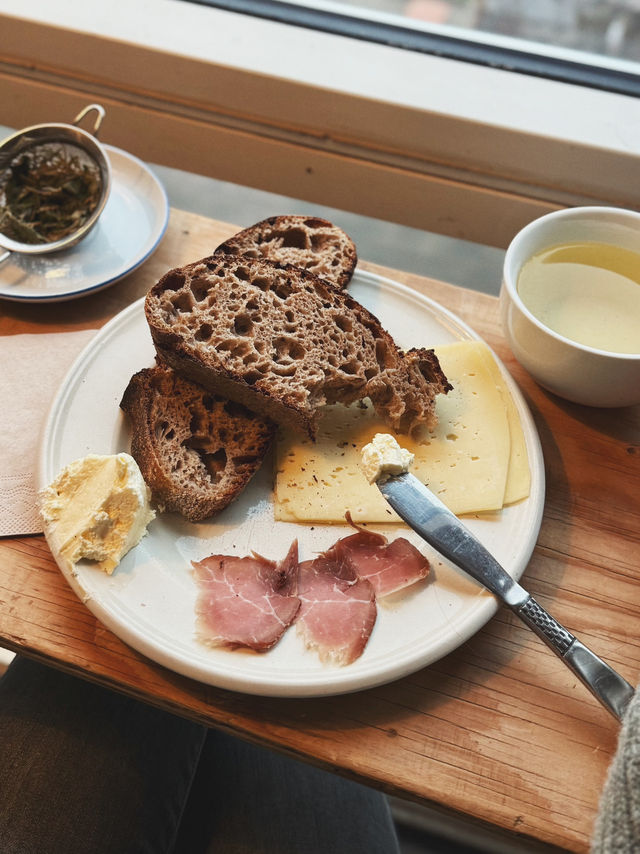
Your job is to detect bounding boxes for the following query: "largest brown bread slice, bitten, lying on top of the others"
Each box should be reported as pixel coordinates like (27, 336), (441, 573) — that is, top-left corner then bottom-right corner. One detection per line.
(145, 253), (451, 437)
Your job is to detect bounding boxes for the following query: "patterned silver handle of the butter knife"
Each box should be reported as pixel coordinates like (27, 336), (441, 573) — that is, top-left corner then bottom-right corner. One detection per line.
(512, 596), (634, 720)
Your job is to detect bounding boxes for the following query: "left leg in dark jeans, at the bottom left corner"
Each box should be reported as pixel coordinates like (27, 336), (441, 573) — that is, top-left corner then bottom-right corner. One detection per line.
(0, 658), (207, 854)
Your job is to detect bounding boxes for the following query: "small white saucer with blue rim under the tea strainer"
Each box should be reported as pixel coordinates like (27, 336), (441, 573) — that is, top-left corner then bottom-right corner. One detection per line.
(0, 145), (169, 302)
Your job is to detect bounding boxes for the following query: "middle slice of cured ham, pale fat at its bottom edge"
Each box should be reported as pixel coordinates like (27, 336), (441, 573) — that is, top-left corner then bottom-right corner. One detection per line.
(296, 552), (377, 665)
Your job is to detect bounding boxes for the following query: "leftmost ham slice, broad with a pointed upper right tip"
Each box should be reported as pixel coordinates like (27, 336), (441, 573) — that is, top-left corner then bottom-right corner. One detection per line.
(192, 541), (300, 651)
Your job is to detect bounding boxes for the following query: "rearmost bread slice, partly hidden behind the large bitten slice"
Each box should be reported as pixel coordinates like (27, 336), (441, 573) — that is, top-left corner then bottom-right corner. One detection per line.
(216, 214), (358, 288)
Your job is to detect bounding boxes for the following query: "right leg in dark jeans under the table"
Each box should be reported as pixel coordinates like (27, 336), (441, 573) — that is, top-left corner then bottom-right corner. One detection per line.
(175, 731), (399, 854)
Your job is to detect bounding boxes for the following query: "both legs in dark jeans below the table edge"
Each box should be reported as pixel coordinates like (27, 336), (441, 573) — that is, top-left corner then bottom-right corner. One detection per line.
(0, 658), (398, 854)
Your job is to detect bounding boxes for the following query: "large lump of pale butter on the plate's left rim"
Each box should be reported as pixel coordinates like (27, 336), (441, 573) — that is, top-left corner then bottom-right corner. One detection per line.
(39, 454), (155, 575)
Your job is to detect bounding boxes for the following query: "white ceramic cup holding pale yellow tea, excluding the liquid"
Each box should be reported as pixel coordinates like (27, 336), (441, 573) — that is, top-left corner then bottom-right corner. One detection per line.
(500, 207), (640, 407)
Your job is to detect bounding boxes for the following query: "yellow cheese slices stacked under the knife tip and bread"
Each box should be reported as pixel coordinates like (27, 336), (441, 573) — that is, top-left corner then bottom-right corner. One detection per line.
(274, 341), (529, 522)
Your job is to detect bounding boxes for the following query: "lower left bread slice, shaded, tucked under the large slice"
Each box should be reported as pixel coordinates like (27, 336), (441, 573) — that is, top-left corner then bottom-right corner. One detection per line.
(120, 366), (275, 522)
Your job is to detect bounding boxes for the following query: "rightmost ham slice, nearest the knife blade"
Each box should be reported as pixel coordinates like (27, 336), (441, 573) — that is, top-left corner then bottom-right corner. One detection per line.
(326, 516), (430, 598)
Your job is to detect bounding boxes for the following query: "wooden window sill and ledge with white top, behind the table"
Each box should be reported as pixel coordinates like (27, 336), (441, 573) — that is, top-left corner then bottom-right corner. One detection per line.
(0, 0), (640, 246)
